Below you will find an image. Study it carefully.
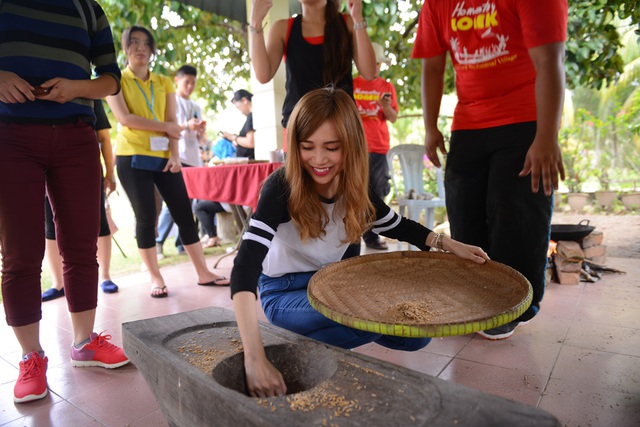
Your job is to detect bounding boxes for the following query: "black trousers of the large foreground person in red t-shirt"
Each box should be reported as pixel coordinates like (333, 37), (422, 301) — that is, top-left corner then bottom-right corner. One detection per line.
(445, 122), (553, 321)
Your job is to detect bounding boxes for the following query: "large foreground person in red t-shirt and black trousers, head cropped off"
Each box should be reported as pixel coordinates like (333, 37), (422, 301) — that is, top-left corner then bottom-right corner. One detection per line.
(412, 0), (568, 339)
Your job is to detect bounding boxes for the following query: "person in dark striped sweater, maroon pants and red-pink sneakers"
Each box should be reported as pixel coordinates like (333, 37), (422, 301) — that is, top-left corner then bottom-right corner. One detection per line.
(0, 0), (129, 402)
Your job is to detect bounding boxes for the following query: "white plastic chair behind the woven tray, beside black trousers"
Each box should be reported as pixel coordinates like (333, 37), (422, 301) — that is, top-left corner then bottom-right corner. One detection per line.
(387, 144), (445, 249)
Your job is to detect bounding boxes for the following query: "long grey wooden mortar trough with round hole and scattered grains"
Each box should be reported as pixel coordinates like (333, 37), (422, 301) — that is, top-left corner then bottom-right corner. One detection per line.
(122, 308), (560, 427)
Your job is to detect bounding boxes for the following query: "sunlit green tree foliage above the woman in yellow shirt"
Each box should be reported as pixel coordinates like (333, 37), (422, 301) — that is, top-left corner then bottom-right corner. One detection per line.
(100, 0), (249, 110)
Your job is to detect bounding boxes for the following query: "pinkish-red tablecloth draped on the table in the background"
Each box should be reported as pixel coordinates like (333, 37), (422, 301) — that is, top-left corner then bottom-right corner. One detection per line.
(182, 163), (282, 209)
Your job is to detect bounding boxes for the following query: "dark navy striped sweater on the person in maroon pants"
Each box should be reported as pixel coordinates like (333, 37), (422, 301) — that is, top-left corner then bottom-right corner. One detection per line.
(0, 0), (120, 124)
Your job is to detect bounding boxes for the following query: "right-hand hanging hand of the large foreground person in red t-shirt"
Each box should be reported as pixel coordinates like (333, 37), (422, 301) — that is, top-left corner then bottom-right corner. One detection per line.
(518, 134), (564, 196)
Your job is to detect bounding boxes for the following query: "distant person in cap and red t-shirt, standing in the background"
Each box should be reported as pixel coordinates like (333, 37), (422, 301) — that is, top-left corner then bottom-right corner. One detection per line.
(353, 43), (398, 250)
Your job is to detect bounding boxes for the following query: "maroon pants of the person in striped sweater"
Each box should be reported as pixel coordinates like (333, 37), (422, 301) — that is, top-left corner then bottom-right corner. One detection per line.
(0, 121), (100, 326)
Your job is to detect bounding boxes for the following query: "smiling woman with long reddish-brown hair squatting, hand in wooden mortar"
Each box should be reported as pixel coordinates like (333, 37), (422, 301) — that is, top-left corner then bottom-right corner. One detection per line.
(231, 88), (489, 397)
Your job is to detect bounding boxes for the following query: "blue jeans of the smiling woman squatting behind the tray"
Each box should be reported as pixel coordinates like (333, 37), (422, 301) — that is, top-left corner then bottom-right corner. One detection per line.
(259, 272), (431, 351)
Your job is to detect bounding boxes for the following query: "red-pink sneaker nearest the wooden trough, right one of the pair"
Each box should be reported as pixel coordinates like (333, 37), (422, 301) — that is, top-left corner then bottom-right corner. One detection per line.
(71, 332), (129, 369)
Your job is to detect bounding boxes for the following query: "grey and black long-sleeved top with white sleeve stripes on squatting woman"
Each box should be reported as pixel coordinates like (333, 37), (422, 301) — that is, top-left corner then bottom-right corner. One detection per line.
(231, 168), (431, 296)
